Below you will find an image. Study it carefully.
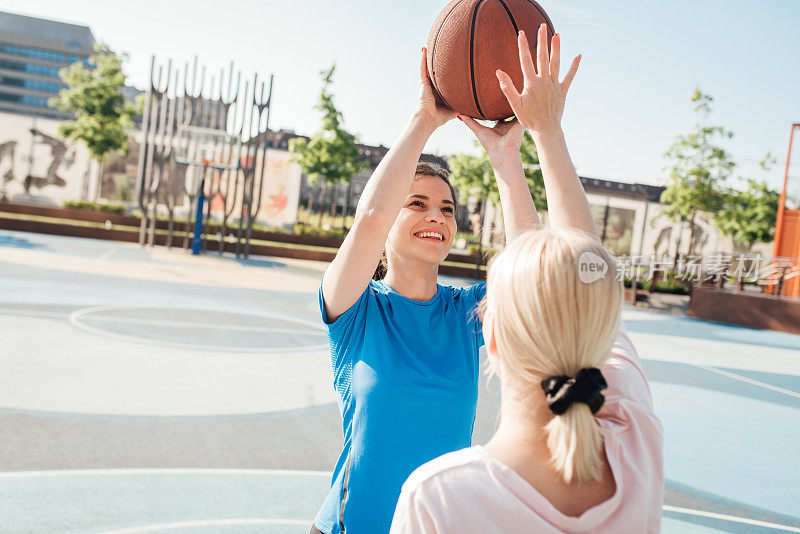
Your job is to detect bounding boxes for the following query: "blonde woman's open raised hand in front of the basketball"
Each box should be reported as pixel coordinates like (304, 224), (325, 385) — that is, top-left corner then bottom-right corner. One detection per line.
(495, 24), (581, 134)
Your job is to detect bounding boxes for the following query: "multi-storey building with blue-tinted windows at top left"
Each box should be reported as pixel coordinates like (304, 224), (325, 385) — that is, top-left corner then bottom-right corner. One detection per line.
(0, 11), (95, 120)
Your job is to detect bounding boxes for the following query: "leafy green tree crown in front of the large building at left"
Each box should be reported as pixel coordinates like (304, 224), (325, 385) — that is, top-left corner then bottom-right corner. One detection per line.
(50, 44), (141, 163)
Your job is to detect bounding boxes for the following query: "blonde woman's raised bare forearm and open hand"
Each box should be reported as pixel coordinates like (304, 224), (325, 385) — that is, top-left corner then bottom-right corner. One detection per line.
(497, 24), (599, 239)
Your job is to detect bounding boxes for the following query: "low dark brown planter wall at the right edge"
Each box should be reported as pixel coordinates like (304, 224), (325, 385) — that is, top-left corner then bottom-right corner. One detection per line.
(689, 287), (800, 334)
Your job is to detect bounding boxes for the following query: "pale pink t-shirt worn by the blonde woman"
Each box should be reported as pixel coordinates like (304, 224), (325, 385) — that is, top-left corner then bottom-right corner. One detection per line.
(391, 327), (664, 534)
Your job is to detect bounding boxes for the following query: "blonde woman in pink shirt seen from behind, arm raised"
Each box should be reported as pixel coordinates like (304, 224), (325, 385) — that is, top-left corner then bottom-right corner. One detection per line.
(391, 24), (664, 534)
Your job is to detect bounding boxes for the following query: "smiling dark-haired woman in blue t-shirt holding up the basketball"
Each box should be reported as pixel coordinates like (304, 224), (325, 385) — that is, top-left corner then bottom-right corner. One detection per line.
(312, 45), (539, 534)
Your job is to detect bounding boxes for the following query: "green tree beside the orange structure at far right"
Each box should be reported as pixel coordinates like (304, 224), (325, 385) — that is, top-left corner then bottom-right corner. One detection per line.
(714, 154), (781, 252)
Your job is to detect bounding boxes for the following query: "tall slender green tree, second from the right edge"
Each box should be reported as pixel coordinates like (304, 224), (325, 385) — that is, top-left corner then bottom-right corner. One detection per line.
(661, 89), (735, 261)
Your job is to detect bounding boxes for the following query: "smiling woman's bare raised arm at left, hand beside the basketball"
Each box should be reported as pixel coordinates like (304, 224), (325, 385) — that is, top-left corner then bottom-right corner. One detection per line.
(322, 48), (456, 322)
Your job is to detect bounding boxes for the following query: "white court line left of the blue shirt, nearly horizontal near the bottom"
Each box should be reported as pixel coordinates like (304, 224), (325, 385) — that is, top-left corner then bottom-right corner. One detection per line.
(0, 467), (331, 478)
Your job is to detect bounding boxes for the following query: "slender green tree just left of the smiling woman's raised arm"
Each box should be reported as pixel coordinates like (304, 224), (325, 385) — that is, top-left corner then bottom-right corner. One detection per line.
(289, 64), (366, 226)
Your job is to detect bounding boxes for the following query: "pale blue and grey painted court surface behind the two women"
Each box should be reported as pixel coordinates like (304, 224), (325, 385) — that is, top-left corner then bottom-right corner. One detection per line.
(0, 231), (800, 534)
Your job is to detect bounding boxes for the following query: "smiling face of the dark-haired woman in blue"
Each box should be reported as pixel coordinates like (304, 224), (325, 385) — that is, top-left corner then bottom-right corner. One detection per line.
(386, 175), (457, 265)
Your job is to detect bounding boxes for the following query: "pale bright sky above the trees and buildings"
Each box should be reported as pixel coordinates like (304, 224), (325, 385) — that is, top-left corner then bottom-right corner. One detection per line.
(0, 0), (800, 193)
